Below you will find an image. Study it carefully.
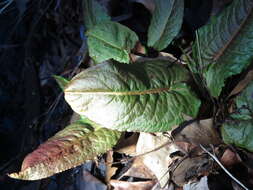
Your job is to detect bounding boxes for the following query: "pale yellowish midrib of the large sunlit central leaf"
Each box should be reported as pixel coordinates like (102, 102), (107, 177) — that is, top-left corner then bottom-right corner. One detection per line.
(65, 88), (170, 96)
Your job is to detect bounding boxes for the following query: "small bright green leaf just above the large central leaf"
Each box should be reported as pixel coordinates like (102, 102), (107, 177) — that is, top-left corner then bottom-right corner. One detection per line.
(86, 22), (138, 63)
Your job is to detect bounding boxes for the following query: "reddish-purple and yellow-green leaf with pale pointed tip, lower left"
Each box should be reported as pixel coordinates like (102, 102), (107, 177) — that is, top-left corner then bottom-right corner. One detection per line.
(9, 121), (120, 180)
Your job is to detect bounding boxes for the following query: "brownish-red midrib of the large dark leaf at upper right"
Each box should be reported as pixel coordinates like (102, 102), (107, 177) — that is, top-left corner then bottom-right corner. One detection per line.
(213, 4), (253, 61)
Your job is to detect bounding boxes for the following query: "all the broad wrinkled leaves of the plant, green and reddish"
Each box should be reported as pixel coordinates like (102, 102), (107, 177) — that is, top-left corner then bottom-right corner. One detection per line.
(10, 0), (253, 180)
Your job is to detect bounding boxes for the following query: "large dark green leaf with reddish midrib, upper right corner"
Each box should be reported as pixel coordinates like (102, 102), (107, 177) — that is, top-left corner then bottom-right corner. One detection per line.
(193, 0), (253, 97)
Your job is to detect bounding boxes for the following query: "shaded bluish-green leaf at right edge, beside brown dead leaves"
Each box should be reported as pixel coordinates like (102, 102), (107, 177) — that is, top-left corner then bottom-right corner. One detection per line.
(221, 82), (253, 152)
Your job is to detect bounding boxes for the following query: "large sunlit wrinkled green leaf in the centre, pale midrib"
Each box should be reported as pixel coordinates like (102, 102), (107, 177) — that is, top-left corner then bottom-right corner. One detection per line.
(65, 60), (200, 132)
